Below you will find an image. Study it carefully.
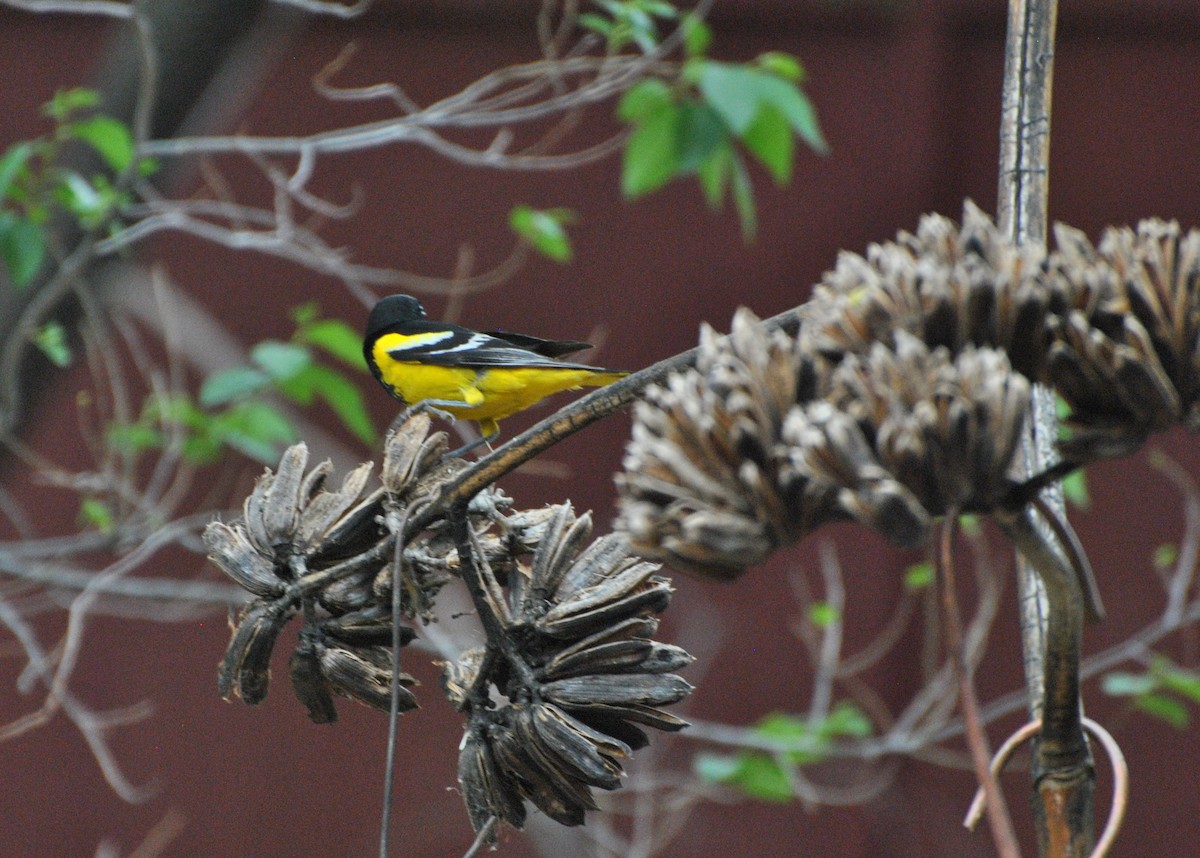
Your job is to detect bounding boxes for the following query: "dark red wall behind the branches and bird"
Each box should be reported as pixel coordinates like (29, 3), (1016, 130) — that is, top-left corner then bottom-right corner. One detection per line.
(0, 0), (1200, 857)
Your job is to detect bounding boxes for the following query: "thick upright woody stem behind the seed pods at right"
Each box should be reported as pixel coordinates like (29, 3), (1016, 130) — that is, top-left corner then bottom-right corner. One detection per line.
(996, 0), (1094, 858)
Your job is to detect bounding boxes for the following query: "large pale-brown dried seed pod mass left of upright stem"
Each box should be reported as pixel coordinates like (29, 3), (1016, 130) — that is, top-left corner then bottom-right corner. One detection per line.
(618, 203), (1066, 577)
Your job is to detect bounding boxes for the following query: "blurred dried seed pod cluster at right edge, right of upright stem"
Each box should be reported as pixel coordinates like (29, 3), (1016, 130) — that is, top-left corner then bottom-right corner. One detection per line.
(1046, 220), (1200, 461)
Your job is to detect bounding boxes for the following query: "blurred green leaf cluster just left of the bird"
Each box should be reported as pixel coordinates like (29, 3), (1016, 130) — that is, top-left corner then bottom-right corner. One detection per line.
(108, 304), (376, 464)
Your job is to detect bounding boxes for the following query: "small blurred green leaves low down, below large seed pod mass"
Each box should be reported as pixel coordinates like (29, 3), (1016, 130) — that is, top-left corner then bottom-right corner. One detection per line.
(694, 701), (871, 803)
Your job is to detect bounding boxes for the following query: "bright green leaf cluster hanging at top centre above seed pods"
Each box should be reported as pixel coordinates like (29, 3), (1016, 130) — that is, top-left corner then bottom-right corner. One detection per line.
(617, 5), (828, 239)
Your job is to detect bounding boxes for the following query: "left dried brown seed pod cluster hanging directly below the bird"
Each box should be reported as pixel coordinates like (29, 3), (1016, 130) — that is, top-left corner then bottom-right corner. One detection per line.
(204, 415), (482, 722)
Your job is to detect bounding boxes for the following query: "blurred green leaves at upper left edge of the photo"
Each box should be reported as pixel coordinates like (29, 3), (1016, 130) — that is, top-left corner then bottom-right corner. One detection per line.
(0, 89), (156, 289)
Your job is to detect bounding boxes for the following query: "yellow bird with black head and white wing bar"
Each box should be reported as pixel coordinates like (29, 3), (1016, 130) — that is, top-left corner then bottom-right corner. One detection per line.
(362, 295), (629, 452)
